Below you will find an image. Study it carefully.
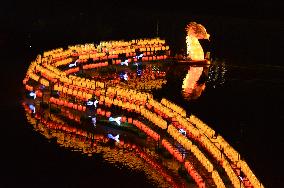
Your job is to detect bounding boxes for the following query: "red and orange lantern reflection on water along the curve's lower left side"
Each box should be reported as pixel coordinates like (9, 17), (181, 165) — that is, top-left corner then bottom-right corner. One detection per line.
(23, 101), (191, 187)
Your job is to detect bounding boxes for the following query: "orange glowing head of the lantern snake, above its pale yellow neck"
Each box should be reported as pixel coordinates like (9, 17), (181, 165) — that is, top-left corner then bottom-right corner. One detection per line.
(186, 22), (210, 40)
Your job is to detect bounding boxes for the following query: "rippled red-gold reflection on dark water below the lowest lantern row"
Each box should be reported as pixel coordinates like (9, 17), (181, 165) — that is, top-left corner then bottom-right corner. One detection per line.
(24, 104), (180, 187)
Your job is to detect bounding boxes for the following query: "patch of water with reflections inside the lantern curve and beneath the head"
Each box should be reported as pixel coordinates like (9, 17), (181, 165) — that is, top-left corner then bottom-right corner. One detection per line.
(84, 60), (227, 101)
